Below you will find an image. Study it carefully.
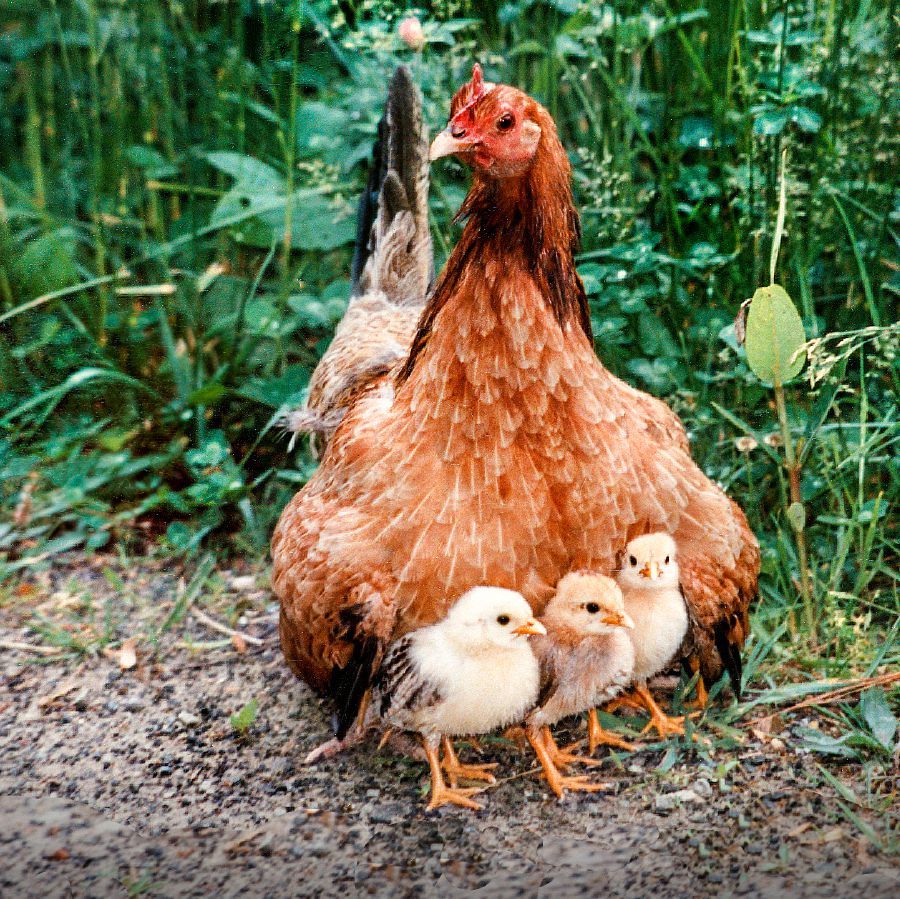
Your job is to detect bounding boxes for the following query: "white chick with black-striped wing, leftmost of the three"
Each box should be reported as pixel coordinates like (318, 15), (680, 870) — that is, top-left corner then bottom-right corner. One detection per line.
(371, 587), (546, 809)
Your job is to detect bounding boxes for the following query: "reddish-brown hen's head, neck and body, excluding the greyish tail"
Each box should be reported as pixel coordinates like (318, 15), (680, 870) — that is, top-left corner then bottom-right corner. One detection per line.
(272, 66), (759, 734)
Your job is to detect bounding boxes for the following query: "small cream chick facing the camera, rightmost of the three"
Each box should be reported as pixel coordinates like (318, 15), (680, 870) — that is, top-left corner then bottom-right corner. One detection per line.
(618, 533), (688, 737)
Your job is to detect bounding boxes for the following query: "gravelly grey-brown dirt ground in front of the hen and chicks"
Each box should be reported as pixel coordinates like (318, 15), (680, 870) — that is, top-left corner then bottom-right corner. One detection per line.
(0, 559), (900, 899)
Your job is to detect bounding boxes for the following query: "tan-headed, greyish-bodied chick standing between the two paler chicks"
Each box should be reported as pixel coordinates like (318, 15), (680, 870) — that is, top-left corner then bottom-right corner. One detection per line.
(525, 572), (634, 798)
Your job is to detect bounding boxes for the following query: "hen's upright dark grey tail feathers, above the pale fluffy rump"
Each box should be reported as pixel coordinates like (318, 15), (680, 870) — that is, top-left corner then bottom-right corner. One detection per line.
(351, 66), (434, 306)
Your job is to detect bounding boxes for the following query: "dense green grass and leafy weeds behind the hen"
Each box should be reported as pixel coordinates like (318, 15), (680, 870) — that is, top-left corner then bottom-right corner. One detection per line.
(0, 0), (900, 758)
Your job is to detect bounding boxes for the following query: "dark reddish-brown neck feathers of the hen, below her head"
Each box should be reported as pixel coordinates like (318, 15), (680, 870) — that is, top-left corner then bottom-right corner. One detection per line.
(397, 107), (593, 386)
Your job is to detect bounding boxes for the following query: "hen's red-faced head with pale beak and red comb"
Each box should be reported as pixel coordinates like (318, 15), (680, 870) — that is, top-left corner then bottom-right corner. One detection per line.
(429, 63), (553, 178)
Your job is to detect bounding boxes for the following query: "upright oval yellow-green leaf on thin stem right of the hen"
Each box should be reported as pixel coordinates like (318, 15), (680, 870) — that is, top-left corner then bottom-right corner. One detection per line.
(744, 284), (806, 384)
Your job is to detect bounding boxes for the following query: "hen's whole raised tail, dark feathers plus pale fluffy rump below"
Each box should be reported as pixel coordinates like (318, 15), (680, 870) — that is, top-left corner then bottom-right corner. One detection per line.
(283, 66), (434, 454)
